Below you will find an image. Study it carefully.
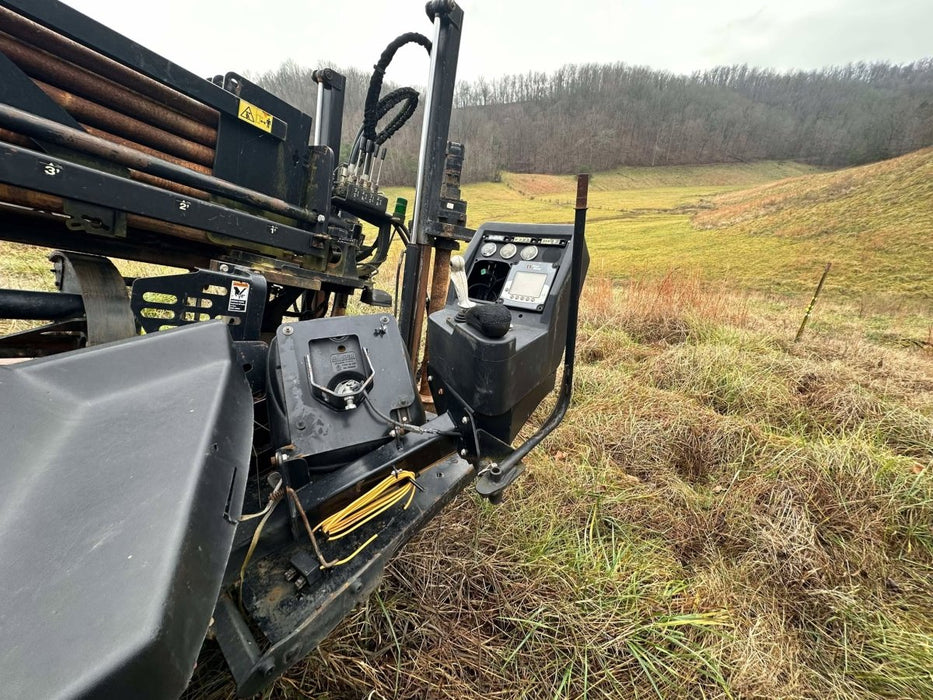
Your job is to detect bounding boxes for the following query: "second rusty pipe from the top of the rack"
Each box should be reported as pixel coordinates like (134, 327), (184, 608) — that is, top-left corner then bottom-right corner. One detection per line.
(0, 32), (217, 147)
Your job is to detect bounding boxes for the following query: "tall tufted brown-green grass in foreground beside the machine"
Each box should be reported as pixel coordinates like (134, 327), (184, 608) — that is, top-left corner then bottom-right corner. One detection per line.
(253, 275), (933, 698)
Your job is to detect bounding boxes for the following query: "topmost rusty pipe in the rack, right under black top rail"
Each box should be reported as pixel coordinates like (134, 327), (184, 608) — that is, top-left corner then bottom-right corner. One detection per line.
(0, 7), (220, 125)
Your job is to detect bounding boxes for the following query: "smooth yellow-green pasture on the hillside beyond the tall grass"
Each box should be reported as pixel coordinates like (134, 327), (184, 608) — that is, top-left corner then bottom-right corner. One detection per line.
(396, 155), (933, 316)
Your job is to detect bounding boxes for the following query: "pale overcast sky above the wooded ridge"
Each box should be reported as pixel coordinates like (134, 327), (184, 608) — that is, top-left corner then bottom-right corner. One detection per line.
(65, 0), (933, 85)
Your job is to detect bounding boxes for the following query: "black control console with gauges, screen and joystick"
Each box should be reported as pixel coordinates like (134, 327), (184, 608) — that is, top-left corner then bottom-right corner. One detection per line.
(428, 223), (586, 443)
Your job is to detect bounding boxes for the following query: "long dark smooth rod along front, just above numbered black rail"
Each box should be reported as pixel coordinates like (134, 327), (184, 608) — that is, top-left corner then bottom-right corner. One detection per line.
(0, 104), (319, 224)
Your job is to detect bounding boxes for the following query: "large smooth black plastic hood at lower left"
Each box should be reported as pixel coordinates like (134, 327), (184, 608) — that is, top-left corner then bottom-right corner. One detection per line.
(0, 321), (253, 698)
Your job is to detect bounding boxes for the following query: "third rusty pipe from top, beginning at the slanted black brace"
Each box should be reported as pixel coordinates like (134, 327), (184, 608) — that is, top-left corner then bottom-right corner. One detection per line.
(35, 80), (214, 166)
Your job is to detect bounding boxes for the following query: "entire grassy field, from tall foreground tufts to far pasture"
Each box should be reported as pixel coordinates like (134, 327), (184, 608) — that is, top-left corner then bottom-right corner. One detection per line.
(3, 150), (933, 699)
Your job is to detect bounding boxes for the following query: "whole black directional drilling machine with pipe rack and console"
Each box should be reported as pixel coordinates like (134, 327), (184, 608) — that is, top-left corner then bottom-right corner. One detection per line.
(0, 0), (586, 698)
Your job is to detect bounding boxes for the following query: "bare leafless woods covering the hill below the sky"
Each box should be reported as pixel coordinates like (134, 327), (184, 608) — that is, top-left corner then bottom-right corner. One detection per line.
(253, 59), (933, 183)
